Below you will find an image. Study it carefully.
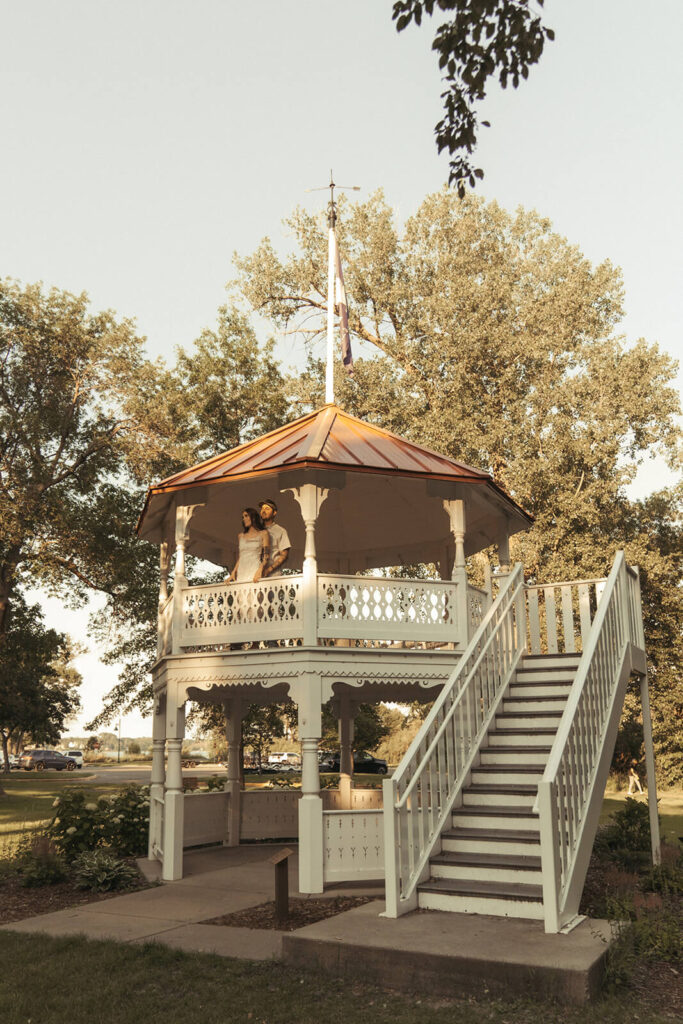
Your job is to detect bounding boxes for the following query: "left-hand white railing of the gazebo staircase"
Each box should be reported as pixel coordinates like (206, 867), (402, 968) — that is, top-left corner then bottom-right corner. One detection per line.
(383, 565), (526, 918)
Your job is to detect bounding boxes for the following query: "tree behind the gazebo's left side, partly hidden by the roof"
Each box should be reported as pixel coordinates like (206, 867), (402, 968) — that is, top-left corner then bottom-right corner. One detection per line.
(85, 306), (290, 729)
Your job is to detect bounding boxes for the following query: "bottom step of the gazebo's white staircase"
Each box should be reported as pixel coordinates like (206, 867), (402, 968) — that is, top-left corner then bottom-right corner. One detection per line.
(418, 879), (543, 921)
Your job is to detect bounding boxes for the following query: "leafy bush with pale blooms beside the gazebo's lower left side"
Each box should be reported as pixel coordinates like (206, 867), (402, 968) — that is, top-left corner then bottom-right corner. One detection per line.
(47, 784), (150, 859)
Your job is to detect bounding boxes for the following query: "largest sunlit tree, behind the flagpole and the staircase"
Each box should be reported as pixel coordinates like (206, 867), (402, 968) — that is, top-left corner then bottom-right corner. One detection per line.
(237, 190), (683, 778)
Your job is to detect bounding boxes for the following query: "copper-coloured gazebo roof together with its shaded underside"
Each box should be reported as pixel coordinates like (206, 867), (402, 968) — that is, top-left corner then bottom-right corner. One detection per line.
(137, 404), (532, 572)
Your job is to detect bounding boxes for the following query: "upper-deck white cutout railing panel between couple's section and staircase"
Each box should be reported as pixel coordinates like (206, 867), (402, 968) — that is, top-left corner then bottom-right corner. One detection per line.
(317, 575), (461, 643)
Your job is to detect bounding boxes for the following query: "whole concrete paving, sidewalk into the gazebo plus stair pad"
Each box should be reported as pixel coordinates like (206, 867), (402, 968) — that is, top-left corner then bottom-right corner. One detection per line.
(2, 844), (610, 1004)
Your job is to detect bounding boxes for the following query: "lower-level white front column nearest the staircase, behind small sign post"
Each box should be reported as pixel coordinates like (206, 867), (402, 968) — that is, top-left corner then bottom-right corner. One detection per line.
(290, 672), (324, 893)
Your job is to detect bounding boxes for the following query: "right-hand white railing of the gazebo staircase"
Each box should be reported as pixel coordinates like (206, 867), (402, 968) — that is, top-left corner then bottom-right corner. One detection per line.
(536, 552), (644, 932)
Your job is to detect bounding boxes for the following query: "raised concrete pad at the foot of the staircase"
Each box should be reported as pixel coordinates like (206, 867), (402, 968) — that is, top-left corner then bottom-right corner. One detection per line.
(283, 901), (610, 1004)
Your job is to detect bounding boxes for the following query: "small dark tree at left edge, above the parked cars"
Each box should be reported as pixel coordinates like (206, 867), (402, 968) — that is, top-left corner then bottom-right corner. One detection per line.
(0, 598), (81, 771)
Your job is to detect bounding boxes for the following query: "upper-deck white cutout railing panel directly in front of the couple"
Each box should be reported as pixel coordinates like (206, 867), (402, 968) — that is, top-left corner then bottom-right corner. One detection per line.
(179, 575), (303, 647)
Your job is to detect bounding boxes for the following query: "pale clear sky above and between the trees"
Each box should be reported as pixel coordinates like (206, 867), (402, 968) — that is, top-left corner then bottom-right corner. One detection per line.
(0, 0), (683, 735)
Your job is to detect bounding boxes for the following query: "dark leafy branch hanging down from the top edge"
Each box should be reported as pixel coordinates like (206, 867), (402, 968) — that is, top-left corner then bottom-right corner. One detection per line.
(391, 0), (555, 192)
